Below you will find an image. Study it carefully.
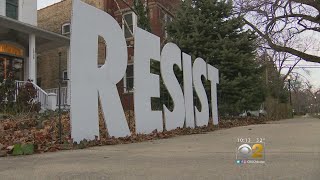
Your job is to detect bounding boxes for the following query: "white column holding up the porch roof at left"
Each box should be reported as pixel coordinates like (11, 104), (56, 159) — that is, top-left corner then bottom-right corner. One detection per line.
(28, 34), (37, 83)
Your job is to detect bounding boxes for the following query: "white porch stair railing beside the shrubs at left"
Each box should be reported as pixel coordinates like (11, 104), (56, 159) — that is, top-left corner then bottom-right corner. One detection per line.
(15, 81), (48, 109)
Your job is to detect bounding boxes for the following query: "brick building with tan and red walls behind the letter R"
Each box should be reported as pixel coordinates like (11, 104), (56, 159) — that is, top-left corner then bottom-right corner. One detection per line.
(37, 0), (180, 110)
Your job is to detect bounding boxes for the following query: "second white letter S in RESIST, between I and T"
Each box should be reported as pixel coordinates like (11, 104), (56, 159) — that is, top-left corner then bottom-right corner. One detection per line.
(193, 58), (209, 126)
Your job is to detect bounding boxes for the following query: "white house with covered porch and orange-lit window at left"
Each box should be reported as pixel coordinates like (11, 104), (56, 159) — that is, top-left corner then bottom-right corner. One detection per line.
(0, 0), (69, 109)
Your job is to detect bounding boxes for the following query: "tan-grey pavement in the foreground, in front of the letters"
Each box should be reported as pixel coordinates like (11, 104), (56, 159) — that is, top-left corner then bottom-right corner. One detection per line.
(0, 118), (320, 180)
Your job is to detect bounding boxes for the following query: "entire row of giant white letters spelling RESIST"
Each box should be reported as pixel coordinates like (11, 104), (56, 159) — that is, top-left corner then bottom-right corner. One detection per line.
(70, 0), (219, 142)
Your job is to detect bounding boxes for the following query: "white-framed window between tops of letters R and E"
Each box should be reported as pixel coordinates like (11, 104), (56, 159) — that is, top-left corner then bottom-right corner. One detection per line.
(122, 12), (137, 38)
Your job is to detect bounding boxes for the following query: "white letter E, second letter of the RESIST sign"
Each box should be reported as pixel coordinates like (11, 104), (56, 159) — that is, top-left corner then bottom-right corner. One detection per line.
(134, 28), (163, 133)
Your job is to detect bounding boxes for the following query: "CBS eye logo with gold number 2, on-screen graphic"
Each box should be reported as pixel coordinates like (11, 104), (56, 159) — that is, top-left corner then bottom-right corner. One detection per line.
(238, 144), (264, 158)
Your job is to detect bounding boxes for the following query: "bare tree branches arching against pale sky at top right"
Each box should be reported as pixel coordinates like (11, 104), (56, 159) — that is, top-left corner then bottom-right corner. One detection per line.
(235, 0), (320, 62)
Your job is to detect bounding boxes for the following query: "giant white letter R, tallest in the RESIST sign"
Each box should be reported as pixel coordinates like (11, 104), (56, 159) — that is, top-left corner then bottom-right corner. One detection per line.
(71, 0), (130, 141)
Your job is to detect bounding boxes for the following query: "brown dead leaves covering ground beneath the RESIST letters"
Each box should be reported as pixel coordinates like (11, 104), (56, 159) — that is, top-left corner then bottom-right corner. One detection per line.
(0, 112), (266, 157)
